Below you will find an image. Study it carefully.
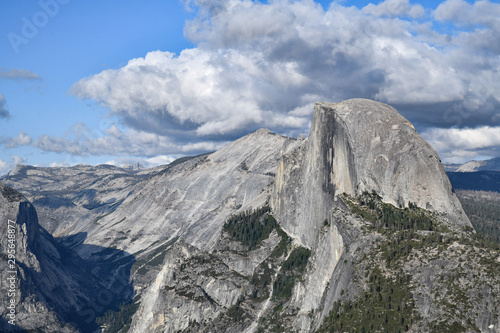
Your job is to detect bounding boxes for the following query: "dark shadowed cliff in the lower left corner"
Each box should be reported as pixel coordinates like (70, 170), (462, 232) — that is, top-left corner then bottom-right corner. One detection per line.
(0, 183), (135, 332)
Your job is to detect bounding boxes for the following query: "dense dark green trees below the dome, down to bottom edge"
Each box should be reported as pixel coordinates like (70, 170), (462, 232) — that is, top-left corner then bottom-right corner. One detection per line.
(318, 192), (428, 332)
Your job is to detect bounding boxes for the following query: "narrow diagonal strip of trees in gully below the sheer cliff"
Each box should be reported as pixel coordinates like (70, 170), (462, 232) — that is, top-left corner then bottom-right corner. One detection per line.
(273, 247), (311, 299)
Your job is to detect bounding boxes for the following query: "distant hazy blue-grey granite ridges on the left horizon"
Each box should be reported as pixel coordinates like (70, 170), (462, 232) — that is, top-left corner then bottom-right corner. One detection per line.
(4, 165), (160, 237)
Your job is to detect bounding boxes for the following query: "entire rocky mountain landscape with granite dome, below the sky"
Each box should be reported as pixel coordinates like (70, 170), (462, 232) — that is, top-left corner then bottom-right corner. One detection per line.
(0, 99), (500, 333)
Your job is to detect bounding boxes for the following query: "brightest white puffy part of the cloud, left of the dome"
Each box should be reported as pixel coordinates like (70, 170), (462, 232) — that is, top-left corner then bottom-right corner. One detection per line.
(72, 49), (306, 136)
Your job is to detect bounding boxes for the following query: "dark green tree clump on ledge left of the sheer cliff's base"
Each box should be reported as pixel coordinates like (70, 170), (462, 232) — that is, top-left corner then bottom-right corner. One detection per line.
(224, 206), (278, 250)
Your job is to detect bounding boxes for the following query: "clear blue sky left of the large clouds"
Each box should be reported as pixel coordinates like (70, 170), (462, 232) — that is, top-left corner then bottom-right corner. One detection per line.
(0, 0), (192, 169)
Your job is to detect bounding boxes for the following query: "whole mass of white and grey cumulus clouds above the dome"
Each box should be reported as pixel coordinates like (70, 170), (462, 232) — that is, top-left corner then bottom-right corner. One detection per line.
(52, 0), (500, 161)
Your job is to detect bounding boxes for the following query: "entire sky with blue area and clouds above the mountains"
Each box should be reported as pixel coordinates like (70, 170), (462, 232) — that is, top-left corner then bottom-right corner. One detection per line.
(0, 0), (500, 175)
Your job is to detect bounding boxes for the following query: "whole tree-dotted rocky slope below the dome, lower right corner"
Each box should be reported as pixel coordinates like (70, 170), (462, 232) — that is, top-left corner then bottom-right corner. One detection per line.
(318, 192), (500, 332)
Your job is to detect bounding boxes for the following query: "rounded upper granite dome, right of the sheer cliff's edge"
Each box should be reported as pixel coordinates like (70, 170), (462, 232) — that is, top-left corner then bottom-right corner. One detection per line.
(298, 99), (469, 226)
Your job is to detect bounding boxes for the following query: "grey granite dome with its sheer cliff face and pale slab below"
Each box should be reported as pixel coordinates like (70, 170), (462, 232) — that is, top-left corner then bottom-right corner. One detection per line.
(271, 99), (470, 327)
